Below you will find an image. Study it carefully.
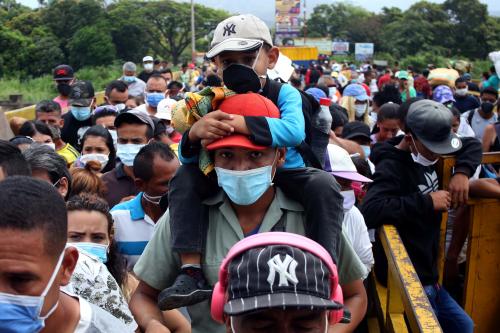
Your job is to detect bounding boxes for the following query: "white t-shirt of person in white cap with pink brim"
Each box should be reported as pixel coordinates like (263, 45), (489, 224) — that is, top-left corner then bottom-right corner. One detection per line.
(342, 206), (375, 279)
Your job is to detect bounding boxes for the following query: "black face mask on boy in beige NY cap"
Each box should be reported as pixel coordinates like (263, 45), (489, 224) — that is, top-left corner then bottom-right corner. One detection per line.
(222, 64), (262, 94)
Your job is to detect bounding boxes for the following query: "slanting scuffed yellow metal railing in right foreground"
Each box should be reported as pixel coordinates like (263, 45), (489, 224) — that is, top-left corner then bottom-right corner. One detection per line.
(377, 225), (442, 333)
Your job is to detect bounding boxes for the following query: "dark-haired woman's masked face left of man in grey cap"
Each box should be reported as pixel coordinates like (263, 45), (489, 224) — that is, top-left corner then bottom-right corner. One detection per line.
(75, 125), (116, 175)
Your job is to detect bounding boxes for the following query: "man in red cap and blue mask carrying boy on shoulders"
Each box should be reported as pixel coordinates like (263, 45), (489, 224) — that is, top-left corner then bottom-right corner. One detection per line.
(130, 93), (366, 333)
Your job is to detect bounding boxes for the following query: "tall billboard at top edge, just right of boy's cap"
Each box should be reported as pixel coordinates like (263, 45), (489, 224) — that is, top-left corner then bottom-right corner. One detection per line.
(275, 0), (301, 38)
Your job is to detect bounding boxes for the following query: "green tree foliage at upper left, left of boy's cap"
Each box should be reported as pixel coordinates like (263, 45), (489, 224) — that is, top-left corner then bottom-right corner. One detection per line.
(0, 0), (229, 77)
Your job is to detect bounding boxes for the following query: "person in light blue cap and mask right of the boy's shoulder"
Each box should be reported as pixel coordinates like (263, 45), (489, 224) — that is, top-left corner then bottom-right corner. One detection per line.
(340, 83), (370, 126)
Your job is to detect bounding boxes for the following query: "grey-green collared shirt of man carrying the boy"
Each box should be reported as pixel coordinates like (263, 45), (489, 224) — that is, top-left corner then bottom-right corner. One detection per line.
(134, 189), (365, 333)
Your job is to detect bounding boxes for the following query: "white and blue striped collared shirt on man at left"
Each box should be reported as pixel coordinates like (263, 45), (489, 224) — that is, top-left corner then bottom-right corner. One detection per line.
(111, 192), (156, 270)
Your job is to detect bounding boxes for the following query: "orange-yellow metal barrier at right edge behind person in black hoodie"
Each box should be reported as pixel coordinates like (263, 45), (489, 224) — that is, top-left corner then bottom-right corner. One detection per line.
(438, 152), (500, 333)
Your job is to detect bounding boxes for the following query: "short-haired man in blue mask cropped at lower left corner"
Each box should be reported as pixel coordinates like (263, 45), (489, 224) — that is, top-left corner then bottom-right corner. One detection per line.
(0, 176), (131, 333)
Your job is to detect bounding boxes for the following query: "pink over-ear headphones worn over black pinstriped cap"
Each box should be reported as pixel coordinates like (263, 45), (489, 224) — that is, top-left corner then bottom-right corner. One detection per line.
(211, 232), (344, 324)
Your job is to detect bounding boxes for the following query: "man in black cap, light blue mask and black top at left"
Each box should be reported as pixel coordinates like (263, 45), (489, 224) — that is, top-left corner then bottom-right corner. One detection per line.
(61, 81), (95, 147)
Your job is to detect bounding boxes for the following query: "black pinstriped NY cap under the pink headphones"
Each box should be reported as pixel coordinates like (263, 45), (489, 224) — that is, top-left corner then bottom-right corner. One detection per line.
(224, 245), (342, 316)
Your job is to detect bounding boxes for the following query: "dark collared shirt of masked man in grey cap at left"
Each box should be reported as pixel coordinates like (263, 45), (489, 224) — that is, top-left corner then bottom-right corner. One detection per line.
(101, 163), (139, 207)
